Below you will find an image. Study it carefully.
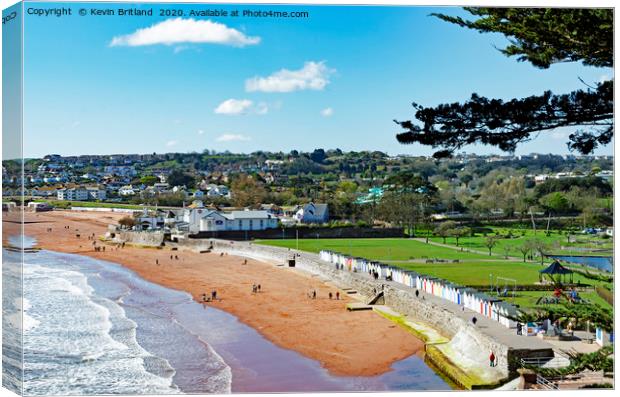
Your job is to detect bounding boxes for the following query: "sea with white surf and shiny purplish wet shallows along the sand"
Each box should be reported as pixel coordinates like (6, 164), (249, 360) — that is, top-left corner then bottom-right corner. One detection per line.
(2, 235), (450, 395)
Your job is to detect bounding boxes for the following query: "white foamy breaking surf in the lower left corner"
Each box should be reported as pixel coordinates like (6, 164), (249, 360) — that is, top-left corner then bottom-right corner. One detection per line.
(23, 253), (179, 395)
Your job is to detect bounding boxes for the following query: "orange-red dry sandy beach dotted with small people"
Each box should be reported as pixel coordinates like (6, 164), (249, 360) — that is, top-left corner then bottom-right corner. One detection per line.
(3, 211), (423, 376)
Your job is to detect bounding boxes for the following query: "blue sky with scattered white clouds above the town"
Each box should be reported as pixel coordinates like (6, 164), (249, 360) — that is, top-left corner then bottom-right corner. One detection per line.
(24, 3), (613, 157)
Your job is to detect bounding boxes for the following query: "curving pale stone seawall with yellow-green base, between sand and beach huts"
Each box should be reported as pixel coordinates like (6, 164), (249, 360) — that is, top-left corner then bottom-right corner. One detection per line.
(178, 240), (553, 389)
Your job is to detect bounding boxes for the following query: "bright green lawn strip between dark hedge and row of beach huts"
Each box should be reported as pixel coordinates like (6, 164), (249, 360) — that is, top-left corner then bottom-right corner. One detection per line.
(257, 238), (489, 262)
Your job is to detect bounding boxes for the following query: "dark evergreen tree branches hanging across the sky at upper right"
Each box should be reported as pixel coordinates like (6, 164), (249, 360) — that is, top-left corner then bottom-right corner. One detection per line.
(394, 7), (614, 158)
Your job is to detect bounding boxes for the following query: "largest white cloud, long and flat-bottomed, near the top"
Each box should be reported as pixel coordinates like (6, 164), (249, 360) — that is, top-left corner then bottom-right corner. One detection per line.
(110, 18), (260, 47)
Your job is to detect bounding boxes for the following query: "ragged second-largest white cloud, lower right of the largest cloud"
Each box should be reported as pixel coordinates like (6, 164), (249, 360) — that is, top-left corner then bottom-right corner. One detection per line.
(245, 62), (335, 92)
